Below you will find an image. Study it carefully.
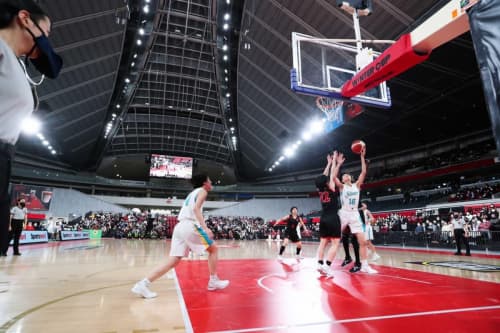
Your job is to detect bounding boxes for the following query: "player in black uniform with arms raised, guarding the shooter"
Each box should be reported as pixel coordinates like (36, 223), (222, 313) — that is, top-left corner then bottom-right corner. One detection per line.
(315, 151), (341, 277)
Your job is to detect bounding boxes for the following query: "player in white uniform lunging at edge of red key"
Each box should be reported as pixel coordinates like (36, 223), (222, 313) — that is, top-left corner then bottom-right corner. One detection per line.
(132, 175), (229, 298)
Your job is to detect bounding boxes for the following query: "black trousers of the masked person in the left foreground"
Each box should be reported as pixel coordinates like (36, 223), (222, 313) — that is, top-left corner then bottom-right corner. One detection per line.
(0, 142), (14, 254)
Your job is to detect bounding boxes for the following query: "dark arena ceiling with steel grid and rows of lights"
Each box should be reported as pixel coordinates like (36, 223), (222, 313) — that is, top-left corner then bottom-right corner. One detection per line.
(14, 0), (490, 180)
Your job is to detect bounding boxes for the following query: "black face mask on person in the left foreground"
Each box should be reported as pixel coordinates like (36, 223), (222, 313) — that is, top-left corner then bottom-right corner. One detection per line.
(26, 21), (63, 79)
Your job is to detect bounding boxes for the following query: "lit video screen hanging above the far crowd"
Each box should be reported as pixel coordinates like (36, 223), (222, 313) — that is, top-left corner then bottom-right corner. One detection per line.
(149, 154), (193, 179)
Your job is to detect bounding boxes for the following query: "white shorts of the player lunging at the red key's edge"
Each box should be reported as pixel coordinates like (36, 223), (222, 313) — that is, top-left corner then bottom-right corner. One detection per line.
(170, 221), (214, 257)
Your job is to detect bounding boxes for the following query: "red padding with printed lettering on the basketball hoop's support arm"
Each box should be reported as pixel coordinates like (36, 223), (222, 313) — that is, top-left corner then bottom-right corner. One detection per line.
(341, 34), (430, 98)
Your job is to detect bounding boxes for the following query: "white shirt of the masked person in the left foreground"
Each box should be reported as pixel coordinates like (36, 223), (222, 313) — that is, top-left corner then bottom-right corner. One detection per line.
(0, 38), (34, 145)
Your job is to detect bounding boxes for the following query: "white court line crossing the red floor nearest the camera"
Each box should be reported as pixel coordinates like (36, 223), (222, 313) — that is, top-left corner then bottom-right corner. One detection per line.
(206, 305), (500, 333)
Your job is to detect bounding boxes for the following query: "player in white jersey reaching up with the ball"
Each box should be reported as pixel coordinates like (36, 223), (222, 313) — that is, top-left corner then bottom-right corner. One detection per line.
(334, 147), (377, 274)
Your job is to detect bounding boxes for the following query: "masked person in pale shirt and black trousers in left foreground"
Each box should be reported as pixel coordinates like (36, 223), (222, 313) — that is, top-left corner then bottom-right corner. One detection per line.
(0, 0), (62, 256)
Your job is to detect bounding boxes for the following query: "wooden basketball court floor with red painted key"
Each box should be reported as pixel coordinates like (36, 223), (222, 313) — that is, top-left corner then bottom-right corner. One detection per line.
(0, 239), (500, 333)
